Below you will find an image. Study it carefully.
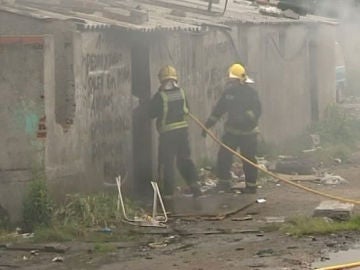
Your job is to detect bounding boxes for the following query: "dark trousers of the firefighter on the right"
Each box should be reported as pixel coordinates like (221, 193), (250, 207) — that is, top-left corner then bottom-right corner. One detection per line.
(216, 133), (258, 187)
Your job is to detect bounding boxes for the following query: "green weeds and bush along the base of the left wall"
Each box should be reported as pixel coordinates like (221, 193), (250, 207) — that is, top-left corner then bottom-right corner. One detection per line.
(0, 173), (144, 245)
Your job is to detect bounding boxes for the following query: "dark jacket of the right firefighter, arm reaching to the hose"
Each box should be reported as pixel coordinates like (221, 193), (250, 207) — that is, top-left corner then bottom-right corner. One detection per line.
(205, 80), (261, 135)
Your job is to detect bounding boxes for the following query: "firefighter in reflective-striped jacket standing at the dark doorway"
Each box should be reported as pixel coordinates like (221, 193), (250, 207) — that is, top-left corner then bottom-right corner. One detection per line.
(150, 66), (201, 197)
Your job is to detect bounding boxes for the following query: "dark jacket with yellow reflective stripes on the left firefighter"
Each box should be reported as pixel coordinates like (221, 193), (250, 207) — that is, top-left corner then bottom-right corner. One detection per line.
(150, 87), (189, 133)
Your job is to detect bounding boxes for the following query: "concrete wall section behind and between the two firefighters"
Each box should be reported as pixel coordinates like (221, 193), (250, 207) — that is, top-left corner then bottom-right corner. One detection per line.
(150, 31), (233, 167)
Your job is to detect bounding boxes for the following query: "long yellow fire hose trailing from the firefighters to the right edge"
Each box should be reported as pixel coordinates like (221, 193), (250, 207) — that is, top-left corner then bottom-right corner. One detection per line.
(189, 113), (360, 205)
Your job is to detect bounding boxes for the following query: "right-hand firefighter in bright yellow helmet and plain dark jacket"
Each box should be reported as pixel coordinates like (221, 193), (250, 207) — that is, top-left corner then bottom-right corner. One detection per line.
(202, 63), (261, 193)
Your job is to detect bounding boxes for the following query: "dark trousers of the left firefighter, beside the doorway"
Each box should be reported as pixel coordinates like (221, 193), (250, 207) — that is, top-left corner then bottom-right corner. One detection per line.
(159, 128), (198, 195)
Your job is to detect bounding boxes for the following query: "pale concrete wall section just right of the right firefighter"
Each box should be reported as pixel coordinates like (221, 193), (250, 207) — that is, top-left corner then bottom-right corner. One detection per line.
(247, 25), (311, 144)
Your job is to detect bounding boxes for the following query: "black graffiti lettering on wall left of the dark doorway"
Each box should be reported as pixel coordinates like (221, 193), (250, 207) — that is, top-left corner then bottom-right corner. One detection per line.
(83, 34), (131, 177)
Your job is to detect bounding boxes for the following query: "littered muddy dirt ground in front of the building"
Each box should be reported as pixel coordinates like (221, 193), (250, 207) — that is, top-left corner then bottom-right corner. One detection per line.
(0, 155), (360, 270)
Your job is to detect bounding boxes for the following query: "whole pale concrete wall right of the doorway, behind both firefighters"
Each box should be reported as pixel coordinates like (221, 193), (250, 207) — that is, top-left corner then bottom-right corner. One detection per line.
(150, 24), (335, 165)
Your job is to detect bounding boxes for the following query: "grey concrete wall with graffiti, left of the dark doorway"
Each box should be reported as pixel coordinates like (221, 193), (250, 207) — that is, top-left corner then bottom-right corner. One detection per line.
(0, 12), (136, 219)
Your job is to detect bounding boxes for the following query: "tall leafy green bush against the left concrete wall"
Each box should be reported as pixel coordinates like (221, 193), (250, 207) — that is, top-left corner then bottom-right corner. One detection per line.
(23, 174), (53, 231)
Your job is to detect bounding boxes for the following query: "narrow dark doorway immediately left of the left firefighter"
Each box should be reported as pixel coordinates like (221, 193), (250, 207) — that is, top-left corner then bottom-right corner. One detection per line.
(131, 40), (152, 197)
